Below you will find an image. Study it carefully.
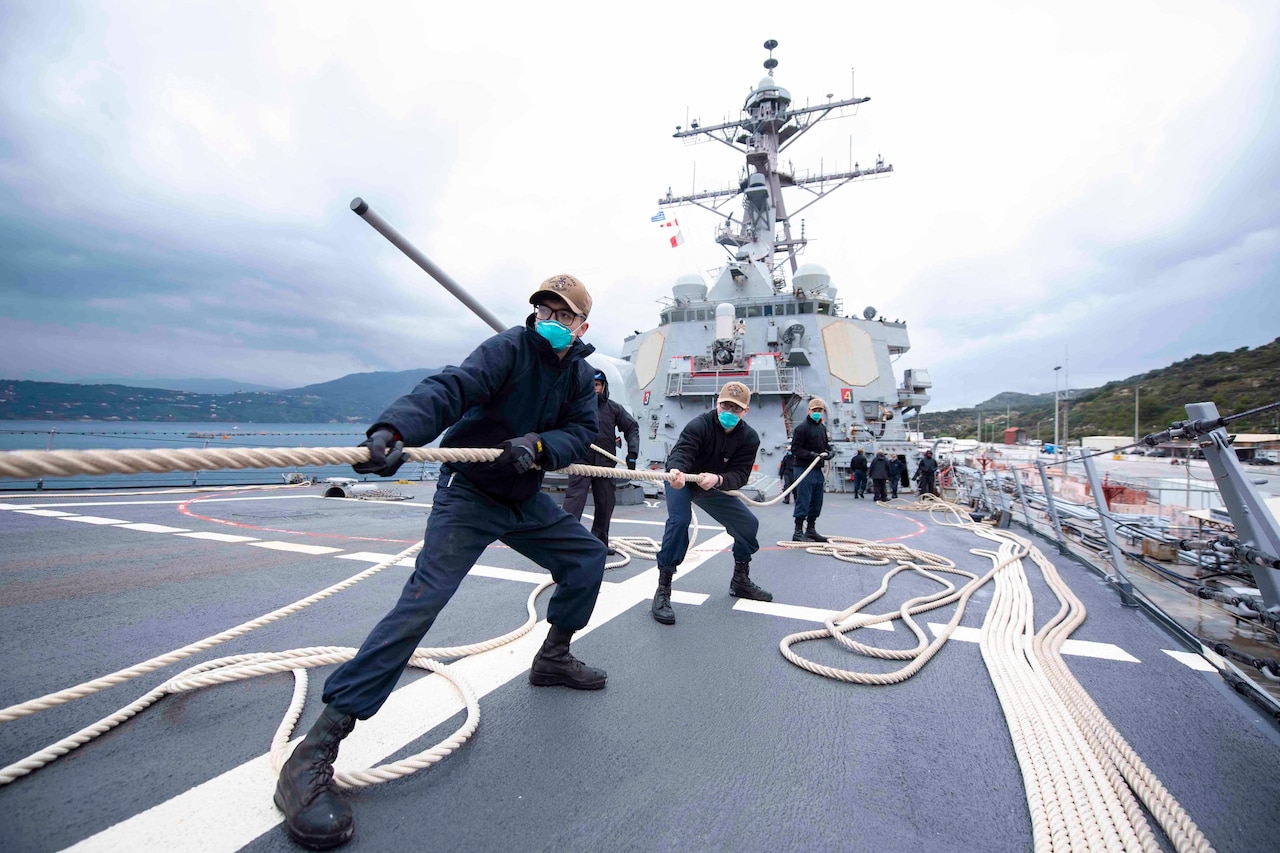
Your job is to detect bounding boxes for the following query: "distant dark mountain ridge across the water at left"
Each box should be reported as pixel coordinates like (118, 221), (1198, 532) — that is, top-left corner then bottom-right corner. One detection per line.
(0, 368), (439, 424)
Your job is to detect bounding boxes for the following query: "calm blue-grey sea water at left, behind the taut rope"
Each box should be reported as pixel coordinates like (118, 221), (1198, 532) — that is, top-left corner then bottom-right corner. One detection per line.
(0, 420), (439, 492)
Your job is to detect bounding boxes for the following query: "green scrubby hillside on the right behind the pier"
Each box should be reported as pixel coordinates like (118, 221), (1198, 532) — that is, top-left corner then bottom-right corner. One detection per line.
(909, 338), (1280, 441)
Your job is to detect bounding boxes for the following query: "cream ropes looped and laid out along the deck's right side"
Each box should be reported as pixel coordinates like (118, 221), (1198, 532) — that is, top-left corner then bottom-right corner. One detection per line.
(780, 494), (1213, 853)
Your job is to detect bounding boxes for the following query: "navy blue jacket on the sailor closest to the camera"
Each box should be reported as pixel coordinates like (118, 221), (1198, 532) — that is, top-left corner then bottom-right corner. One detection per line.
(369, 314), (598, 501)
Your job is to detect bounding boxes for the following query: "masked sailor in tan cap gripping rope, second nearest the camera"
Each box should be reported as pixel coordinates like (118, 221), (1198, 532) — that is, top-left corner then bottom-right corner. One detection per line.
(650, 382), (773, 625)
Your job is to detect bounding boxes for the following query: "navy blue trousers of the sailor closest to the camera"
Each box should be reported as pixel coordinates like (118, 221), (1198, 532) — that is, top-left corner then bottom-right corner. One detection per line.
(324, 474), (604, 720)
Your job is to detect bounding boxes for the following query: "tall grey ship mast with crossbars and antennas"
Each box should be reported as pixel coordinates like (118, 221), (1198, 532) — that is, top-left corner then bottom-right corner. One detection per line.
(658, 38), (893, 273)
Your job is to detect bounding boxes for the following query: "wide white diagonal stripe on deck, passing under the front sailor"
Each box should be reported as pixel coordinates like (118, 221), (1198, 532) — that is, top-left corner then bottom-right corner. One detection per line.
(67, 533), (733, 853)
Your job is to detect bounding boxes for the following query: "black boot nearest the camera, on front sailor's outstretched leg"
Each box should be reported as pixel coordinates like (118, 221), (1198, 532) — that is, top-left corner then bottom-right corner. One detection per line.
(275, 704), (356, 850)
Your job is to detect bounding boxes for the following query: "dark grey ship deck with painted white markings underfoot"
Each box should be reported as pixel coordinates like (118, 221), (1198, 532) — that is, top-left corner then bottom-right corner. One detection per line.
(0, 484), (1280, 852)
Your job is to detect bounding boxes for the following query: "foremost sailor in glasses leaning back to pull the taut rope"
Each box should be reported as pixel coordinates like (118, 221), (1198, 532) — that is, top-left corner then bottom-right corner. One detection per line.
(275, 275), (605, 849)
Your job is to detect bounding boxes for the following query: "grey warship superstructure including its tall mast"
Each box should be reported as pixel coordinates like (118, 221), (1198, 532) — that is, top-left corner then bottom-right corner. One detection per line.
(622, 40), (931, 488)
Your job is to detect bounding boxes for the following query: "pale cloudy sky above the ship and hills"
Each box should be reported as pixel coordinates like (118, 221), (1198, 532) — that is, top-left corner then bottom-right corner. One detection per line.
(0, 0), (1280, 410)
